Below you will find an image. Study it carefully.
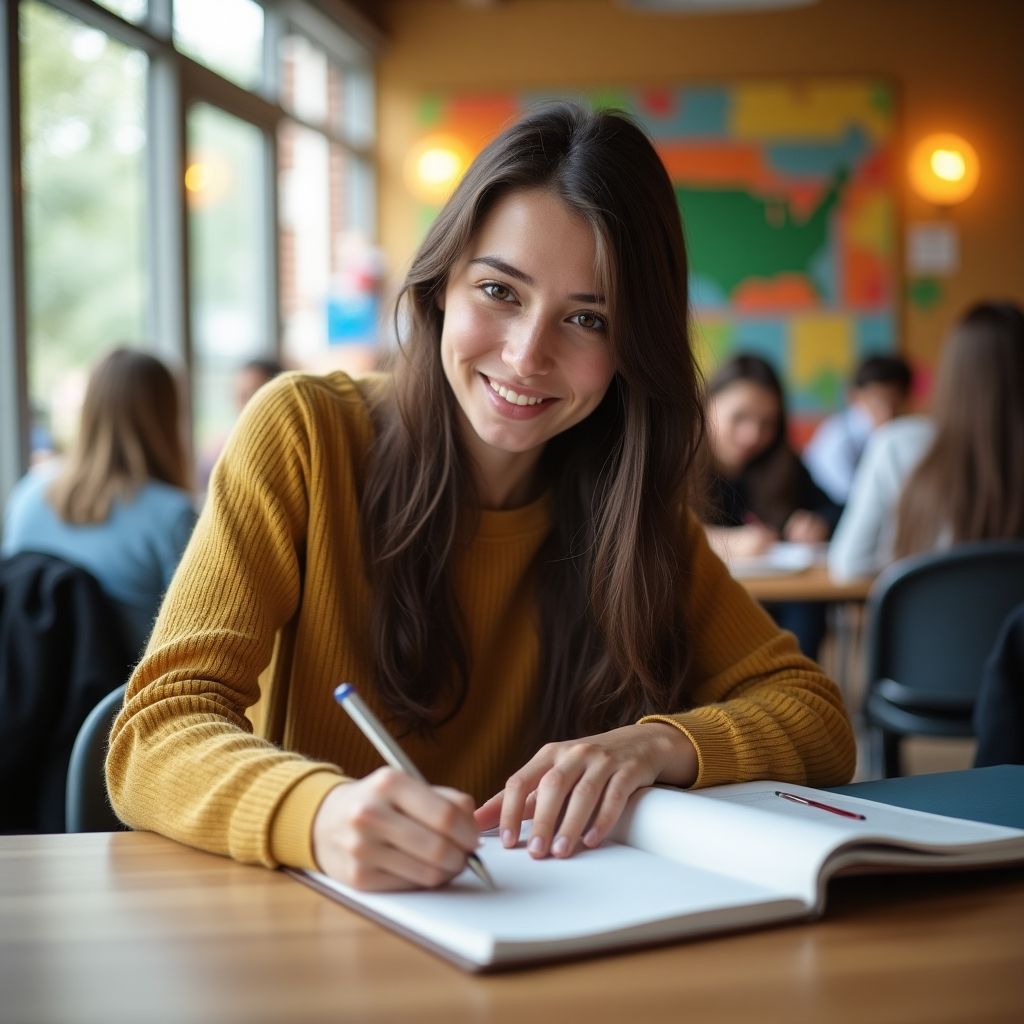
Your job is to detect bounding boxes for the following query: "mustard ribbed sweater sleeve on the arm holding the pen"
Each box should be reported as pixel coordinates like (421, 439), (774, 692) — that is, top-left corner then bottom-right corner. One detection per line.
(106, 375), (352, 864)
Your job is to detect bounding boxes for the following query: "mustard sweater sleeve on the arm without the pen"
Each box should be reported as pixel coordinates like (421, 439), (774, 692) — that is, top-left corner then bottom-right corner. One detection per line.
(641, 519), (856, 786)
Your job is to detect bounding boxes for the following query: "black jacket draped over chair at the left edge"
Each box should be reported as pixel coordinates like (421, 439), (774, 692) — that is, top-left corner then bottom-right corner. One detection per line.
(0, 552), (134, 833)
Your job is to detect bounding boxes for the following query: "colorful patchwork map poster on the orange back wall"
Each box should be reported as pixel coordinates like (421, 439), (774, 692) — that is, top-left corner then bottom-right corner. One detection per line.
(411, 78), (898, 440)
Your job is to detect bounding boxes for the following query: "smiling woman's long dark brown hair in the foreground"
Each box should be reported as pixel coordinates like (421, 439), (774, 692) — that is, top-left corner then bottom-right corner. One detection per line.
(361, 103), (703, 739)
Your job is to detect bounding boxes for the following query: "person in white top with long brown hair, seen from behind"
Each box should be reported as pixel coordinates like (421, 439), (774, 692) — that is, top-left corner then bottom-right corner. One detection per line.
(828, 302), (1024, 580)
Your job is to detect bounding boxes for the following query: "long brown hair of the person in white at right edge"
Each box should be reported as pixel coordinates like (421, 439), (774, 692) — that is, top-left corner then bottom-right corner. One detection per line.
(893, 302), (1024, 558)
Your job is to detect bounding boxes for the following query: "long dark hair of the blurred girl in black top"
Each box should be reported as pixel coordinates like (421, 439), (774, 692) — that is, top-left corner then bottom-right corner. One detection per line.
(703, 352), (800, 529)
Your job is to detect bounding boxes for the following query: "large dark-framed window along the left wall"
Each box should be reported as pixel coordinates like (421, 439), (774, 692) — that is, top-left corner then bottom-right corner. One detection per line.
(0, 0), (377, 499)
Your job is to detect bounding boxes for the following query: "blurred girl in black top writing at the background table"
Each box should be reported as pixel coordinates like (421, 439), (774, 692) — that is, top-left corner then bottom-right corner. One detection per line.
(703, 353), (840, 657)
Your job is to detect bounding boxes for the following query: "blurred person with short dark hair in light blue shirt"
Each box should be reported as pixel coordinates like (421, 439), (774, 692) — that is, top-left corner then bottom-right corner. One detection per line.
(803, 355), (912, 505)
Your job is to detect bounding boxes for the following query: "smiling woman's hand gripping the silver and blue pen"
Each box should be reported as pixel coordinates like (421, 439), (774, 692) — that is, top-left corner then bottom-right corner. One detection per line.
(313, 768), (479, 892)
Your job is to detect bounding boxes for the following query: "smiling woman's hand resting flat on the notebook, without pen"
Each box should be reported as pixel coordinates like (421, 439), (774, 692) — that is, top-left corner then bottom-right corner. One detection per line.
(476, 722), (697, 857)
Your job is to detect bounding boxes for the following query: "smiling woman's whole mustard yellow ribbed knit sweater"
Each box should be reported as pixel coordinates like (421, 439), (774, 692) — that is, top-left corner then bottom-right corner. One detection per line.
(106, 374), (854, 868)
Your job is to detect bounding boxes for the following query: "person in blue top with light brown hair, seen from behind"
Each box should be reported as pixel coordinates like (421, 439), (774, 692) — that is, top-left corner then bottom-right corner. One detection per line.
(3, 348), (196, 653)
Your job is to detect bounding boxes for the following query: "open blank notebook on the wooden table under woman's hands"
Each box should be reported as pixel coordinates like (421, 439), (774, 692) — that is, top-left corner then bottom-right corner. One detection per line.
(291, 782), (1024, 971)
